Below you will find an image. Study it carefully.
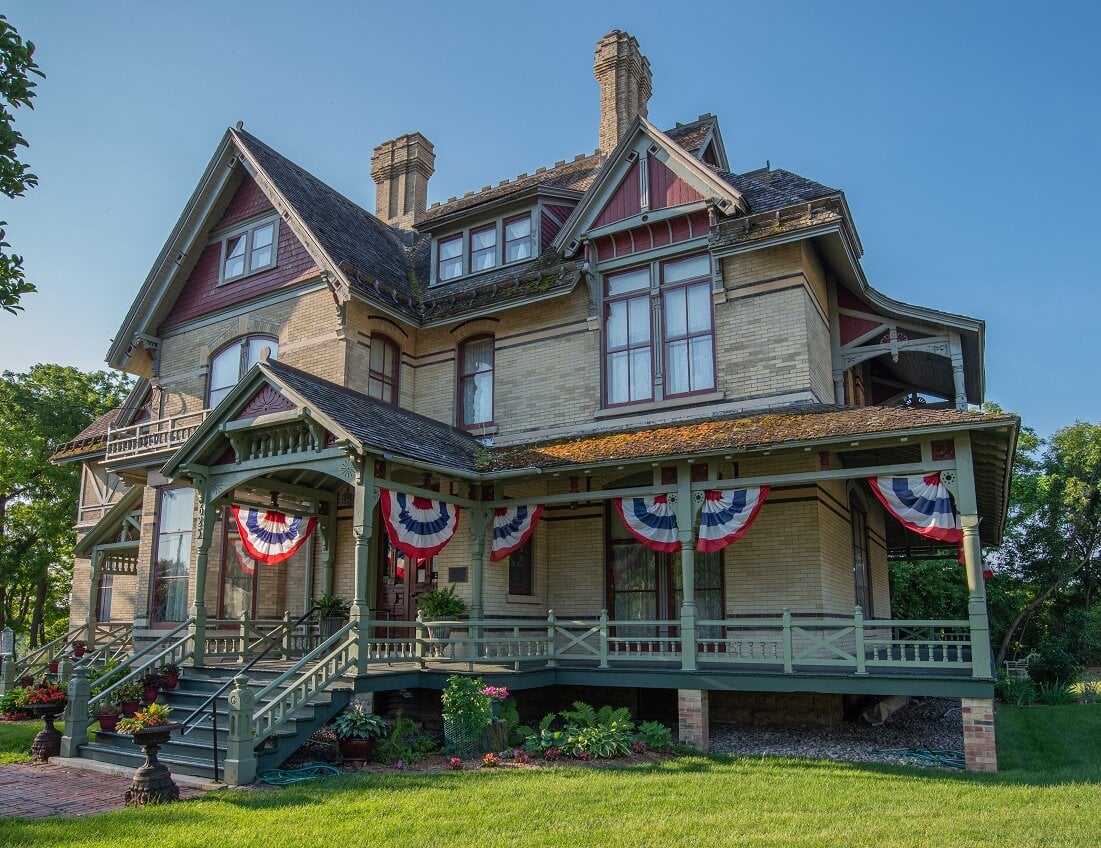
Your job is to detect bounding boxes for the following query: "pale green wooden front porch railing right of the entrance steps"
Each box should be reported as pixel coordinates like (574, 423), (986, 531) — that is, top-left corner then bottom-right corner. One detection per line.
(347, 610), (989, 677)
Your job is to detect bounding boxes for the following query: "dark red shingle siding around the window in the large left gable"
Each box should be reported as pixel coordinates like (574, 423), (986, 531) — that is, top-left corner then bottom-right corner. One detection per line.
(162, 178), (318, 327)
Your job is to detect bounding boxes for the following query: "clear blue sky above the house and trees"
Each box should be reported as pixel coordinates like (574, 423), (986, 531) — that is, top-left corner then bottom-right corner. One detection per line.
(0, 0), (1101, 435)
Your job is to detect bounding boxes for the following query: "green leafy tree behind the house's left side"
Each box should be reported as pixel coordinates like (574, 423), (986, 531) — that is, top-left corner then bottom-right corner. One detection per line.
(0, 365), (129, 644)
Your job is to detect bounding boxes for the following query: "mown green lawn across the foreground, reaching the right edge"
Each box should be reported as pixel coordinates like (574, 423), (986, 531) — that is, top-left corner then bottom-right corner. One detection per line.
(0, 707), (1101, 848)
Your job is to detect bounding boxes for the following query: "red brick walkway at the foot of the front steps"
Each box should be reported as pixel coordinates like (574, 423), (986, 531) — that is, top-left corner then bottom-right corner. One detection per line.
(0, 763), (201, 818)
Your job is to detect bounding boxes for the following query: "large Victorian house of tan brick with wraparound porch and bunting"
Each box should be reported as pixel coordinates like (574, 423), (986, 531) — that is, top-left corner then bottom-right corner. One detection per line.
(25, 31), (1018, 782)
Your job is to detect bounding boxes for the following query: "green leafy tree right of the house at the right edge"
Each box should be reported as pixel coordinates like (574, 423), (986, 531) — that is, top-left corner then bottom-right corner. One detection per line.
(998, 422), (1101, 666)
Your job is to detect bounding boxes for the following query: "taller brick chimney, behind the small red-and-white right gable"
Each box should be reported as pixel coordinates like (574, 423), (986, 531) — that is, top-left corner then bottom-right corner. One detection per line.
(592, 30), (653, 154)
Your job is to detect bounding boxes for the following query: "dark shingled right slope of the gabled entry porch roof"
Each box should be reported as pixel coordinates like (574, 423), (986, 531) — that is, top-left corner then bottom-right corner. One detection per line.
(265, 360), (484, 471)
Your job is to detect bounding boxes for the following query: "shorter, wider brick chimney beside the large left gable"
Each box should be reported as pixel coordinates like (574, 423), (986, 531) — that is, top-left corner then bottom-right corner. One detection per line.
(371, 132), (436, 230)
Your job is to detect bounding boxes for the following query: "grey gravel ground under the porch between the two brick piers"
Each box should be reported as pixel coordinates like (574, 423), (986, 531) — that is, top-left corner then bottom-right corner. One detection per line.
(711, 698), (963, 765)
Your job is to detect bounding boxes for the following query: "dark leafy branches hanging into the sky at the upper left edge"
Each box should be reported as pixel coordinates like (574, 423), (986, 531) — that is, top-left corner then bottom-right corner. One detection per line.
(0, 14), (45, 315)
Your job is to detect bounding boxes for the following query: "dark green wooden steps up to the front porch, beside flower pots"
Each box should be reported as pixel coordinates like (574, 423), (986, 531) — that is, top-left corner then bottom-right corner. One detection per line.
(79, 666), (351, 780)
